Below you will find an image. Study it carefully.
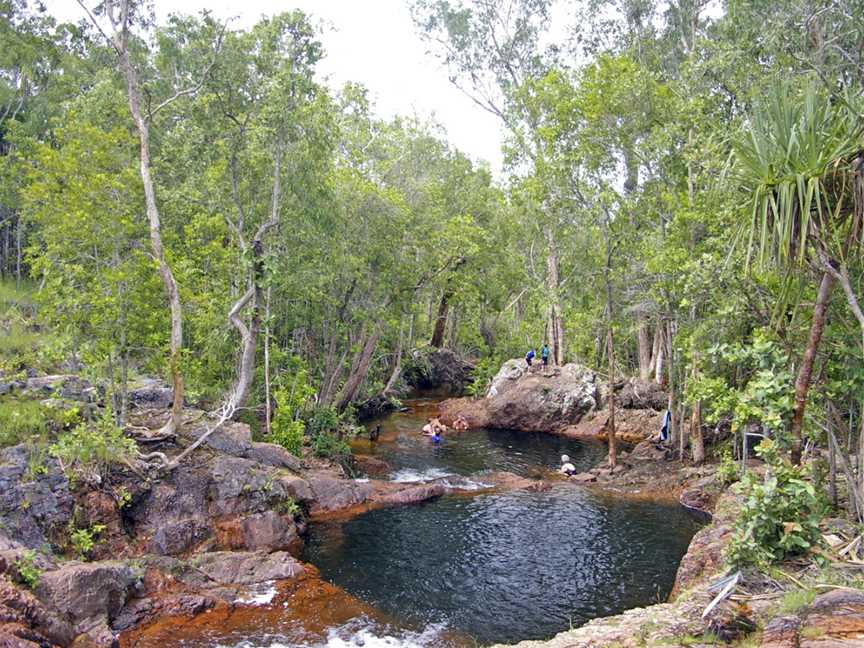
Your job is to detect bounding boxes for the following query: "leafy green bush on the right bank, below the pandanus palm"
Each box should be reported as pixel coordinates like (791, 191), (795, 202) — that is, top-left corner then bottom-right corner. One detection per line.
(726, 439), (824, 568)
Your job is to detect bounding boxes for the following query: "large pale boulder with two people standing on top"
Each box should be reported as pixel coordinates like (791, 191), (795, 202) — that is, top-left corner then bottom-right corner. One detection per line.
(439, 360), (599, 432)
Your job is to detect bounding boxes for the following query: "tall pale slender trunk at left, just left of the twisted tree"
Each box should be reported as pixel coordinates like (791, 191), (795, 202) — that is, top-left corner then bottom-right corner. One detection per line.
(115, 31), (183, 432)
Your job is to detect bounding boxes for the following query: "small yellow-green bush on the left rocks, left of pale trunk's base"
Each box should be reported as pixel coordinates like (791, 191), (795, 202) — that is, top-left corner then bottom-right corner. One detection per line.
(49, 410), (136, 480)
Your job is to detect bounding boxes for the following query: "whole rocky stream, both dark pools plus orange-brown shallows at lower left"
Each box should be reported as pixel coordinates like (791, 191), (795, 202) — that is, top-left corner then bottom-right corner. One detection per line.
(141, 399), (700, 648)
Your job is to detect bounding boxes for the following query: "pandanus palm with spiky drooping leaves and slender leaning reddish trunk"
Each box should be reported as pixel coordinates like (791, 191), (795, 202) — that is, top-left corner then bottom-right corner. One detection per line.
(735, 84), (864, 463)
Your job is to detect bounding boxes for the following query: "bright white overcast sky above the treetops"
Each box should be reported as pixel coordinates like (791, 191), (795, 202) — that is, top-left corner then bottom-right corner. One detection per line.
(46, 0), (502, 175)
